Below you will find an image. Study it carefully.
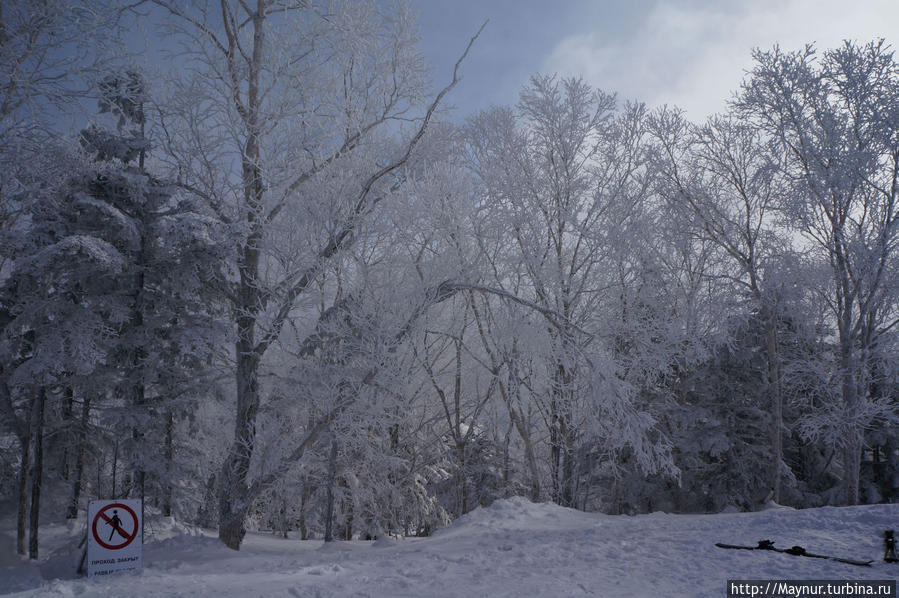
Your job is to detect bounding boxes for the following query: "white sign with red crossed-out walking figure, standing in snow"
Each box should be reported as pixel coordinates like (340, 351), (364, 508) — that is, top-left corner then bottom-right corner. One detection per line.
(87, 499), (143, 577)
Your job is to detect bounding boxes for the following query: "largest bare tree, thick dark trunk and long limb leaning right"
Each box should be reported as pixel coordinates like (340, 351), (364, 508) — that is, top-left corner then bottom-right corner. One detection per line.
(144, 0), (482, 549)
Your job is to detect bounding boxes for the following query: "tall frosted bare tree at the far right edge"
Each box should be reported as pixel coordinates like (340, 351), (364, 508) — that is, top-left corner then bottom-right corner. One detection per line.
(736, 40), (899, 504)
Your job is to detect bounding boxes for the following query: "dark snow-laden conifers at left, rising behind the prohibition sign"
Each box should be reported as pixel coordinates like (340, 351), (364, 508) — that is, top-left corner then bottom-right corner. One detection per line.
(2, 73), (222, 556)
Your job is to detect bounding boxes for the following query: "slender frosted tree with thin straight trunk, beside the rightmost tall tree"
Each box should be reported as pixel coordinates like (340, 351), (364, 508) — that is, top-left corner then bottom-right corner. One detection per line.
(652, 110), (787, 502)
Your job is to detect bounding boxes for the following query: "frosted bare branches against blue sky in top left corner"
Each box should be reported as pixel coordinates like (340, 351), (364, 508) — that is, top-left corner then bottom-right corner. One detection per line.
(0, 0), (124, 274)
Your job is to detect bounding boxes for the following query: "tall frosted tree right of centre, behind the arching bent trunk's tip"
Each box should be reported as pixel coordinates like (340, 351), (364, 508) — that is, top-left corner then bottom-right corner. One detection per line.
(468, 76), (676, 506)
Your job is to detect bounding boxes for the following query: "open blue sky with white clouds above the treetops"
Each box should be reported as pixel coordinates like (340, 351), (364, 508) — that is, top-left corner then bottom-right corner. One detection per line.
(413, 0), (899, 119)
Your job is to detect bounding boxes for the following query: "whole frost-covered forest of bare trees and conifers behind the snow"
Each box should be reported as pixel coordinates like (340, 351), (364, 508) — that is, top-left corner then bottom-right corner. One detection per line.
(0, 0), (899, 558)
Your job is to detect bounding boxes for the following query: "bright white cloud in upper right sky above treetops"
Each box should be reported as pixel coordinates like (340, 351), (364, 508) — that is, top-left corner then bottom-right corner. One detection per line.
(541, 0), (899, 119)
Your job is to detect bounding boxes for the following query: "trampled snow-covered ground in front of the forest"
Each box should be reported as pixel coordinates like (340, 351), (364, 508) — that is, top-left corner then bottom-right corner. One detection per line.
(0, 499), (899, 598)
